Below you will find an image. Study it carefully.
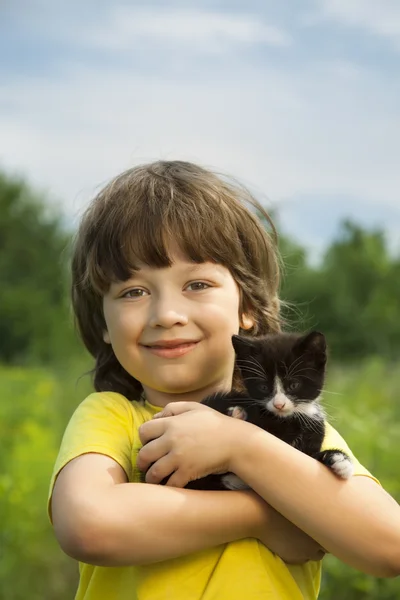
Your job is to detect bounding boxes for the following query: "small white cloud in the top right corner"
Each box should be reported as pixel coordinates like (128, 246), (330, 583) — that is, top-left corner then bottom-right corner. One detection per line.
(316, 0), (400, 48)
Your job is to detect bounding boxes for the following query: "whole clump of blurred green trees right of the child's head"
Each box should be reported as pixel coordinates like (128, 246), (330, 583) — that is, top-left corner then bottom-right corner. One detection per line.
(282, 221), (400, 361)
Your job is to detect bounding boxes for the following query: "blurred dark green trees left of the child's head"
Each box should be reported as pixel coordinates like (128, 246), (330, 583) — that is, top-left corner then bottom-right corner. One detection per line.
(0, 173), (80, 363)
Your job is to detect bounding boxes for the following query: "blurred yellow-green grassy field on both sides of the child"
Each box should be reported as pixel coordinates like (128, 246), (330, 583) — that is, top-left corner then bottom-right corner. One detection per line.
(0, 359), (400, 600)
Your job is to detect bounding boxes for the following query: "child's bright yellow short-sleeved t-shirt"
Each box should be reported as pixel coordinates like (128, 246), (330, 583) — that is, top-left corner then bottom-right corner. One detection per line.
(48, 392), (375, 600)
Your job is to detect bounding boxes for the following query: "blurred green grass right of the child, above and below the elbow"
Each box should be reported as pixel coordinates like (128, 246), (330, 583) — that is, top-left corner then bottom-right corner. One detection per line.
(320, 357), (400, 600)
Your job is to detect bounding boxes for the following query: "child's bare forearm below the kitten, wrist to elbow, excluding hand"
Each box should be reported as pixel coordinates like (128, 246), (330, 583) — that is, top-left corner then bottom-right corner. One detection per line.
(230, 423), (400, 577)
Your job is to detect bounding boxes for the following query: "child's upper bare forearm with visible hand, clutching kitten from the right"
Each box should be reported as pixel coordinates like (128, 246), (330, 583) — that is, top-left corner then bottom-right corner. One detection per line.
(137, 402), (400, 577)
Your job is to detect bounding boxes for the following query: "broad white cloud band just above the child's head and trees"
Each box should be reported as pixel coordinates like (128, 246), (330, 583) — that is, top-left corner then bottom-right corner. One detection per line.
(0, 59), (400, 223)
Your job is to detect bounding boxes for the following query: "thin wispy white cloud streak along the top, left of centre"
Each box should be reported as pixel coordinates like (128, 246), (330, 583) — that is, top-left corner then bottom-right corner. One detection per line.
(17, 6), (293, 53)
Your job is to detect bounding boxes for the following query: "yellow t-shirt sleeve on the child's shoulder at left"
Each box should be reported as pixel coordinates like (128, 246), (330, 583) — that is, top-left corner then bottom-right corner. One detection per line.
(47, 392), (133, 521)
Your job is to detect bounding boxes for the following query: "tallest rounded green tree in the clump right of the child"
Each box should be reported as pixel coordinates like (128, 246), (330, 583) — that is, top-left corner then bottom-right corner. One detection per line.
(314, 221), (391, 359)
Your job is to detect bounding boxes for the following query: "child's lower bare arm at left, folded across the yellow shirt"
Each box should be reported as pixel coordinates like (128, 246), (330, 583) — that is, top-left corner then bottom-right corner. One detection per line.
(52, 454), (322, 566)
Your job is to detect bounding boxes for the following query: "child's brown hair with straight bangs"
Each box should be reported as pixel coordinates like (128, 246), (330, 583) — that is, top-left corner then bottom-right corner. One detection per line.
(72, 161), (280, 399)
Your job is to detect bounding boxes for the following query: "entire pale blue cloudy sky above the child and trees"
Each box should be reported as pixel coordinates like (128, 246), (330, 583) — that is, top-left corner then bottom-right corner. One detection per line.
(0, 0), (400, 258)
